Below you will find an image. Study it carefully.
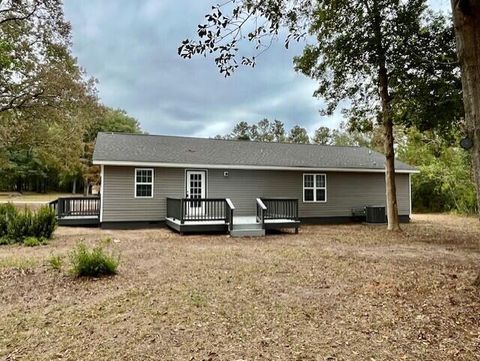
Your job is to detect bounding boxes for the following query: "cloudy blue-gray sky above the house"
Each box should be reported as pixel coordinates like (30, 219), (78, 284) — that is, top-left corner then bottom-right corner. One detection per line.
(65, 0), (448, 137)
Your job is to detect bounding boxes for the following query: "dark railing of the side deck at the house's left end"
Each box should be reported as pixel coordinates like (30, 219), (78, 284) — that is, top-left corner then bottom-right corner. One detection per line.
(48, 197), (100, 218)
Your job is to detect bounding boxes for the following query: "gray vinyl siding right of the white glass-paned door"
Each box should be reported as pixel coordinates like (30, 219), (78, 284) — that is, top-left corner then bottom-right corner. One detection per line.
(208, 169), (410, 217)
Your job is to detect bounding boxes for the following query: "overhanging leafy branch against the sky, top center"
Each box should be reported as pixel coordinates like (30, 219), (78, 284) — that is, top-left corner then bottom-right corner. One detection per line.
(178, 0), (312, 77)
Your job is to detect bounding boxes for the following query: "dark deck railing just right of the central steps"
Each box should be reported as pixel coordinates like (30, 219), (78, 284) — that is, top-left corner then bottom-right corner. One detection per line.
(257, 198), (298, 223)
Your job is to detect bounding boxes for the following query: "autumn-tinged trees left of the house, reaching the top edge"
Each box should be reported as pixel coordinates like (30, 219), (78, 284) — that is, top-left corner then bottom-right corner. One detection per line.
(0, 0), (141, 192)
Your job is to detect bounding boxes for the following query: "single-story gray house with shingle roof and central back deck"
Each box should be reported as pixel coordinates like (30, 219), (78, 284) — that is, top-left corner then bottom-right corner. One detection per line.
(87, 133), (417, 235)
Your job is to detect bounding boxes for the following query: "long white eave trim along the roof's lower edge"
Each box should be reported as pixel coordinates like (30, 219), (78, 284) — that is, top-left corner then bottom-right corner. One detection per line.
(93, 160), (420, 174)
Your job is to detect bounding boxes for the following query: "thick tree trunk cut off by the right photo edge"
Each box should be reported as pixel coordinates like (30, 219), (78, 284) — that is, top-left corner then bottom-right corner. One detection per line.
(451, 0), (480, 286)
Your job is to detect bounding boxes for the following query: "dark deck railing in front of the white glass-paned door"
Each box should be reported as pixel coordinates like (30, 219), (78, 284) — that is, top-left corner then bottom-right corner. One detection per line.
(167, 198), (235, 227)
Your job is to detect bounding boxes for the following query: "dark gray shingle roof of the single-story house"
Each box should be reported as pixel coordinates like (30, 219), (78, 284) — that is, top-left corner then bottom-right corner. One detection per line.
(93, 133), (415, 171)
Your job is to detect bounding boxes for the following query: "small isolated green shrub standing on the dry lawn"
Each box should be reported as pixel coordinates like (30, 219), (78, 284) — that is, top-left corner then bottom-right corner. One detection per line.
(70, 243), (119, 277)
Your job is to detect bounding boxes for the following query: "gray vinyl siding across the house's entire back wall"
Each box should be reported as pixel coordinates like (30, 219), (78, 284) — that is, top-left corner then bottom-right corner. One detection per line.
(103, 166), (410, 222)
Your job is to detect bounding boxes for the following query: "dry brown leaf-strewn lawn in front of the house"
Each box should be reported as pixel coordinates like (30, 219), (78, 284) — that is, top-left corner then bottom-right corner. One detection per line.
(0, 215), (480, 361)
